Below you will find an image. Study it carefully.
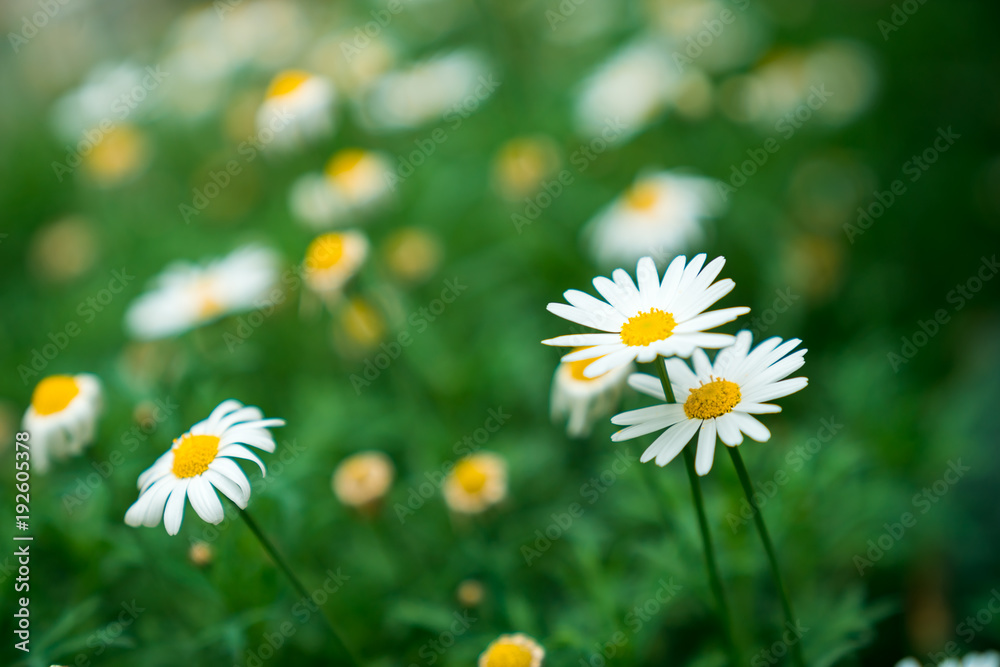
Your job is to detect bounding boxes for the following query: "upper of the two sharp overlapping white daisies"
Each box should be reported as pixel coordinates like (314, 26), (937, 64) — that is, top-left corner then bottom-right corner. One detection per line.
(542, 254), (750, 378)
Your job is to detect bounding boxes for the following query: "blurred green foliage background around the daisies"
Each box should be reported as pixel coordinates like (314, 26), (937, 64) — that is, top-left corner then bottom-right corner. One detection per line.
(0, 0), (1000, 667)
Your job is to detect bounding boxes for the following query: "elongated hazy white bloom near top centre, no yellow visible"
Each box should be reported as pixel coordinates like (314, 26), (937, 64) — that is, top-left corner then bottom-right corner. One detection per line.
(366, 50), (500, 130)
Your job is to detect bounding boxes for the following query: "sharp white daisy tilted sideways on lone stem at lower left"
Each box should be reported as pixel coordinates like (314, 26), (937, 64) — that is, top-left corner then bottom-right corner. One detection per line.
(125, 399), (285, 535)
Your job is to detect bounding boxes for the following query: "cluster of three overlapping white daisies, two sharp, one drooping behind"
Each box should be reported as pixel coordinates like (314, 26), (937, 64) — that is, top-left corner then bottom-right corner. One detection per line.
(543, 254), (807, 475)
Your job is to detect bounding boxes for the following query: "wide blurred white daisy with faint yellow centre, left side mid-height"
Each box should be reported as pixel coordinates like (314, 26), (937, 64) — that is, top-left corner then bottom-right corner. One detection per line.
(125, 246), (278, 340)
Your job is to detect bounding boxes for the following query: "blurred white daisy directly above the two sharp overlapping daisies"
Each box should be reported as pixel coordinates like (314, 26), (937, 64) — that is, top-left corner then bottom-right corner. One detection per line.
(587, 171), (722, 265)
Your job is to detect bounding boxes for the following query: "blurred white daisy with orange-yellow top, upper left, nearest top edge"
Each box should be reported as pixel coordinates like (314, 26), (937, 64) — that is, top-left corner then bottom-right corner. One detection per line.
(257, 70), (337, 148)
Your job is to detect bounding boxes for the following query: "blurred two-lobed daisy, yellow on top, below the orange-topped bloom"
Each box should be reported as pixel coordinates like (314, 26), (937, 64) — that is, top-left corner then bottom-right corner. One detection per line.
(291, 148), (394, 228)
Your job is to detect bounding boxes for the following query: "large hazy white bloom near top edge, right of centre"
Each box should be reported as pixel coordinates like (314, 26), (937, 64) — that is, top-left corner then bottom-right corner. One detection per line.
(576, 41), (681, 142)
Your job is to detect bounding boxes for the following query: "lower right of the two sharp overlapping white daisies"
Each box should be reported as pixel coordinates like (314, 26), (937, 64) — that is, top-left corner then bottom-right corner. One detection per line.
(611, 331), (808, 475)
